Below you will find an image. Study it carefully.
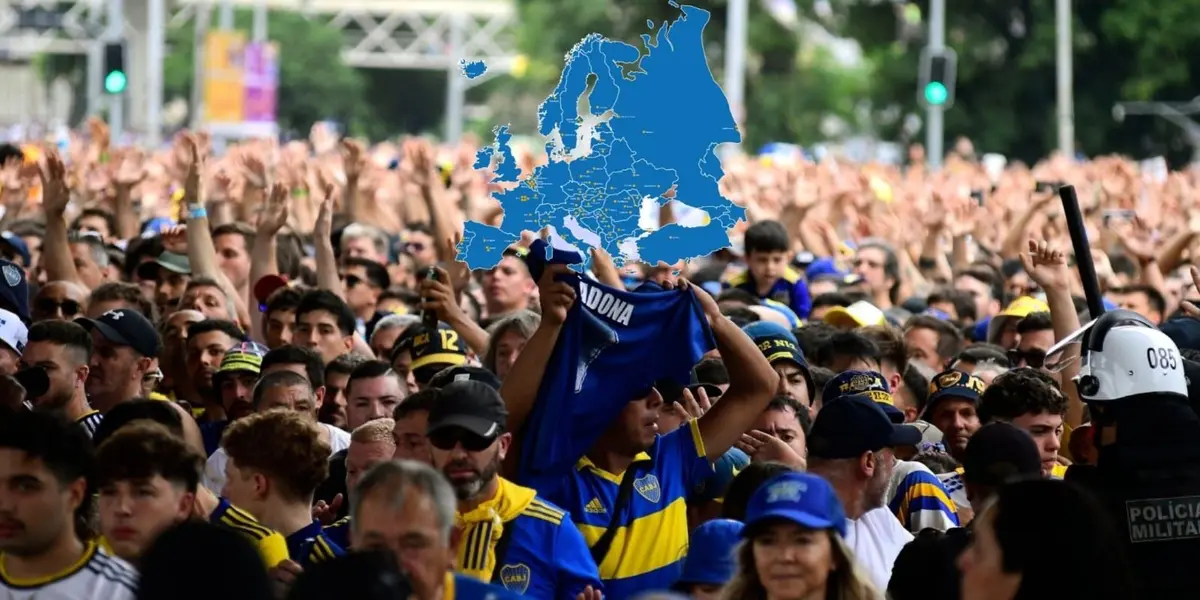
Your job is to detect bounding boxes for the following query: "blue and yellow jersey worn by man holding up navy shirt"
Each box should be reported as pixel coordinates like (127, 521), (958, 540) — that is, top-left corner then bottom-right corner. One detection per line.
(535, 420), (713, 600)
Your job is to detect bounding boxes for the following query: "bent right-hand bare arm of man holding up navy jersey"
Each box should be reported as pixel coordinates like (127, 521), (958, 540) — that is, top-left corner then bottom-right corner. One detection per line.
(696, 280), (779, 461)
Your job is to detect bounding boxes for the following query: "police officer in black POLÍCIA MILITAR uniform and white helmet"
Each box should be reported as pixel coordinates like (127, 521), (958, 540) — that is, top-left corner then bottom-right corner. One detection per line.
(1065, 311), (1200, 598)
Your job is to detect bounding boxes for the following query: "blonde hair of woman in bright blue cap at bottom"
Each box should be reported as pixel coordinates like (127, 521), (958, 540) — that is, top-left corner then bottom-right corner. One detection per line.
(721, 529), (884, 600)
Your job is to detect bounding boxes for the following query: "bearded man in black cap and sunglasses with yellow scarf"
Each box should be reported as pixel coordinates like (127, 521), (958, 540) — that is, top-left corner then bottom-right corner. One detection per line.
(428, 380), (601, 600)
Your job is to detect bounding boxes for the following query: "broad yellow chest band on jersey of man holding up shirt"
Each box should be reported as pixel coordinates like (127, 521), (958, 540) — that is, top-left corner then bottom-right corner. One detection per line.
(576, 497), (688, 580)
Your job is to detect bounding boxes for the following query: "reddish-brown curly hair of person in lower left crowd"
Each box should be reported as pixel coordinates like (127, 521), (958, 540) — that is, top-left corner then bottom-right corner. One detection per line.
(221, 409), (331, 502)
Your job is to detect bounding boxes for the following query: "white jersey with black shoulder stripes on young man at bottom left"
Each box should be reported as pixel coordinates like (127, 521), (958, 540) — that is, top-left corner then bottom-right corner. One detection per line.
(0, 542), (138, 600)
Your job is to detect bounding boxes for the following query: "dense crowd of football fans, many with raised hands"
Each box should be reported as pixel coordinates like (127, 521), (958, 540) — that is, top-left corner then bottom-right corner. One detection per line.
(0, 120), (1200, 600)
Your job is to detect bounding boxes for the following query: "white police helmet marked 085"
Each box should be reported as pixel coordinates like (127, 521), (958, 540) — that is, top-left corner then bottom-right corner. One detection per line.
(1072, 311), (1188, 402)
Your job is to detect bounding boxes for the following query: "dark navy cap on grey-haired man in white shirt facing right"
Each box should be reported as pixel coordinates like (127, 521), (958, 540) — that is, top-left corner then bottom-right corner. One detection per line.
(809, 395), (920, 458)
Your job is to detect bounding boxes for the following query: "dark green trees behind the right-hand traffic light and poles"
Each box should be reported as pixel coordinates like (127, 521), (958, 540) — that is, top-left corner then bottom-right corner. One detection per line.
(825, 0), (1200, 162)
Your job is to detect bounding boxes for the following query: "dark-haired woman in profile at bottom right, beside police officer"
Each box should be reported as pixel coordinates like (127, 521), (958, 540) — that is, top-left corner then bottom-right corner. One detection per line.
(959, 480), (1136, 600)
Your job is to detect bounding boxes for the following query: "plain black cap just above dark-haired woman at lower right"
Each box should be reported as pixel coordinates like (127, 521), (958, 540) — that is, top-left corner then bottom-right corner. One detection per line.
(962, 421), (1042, 486)
